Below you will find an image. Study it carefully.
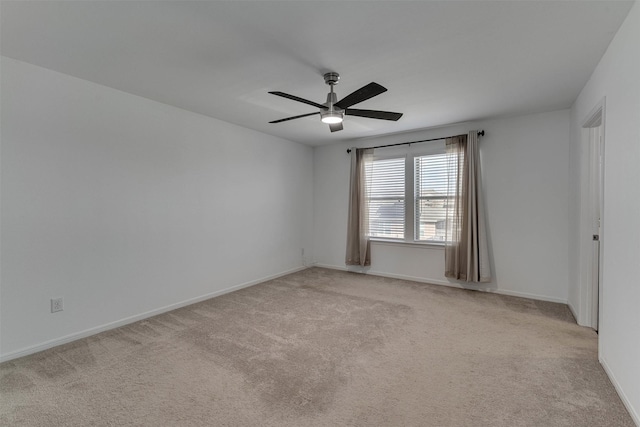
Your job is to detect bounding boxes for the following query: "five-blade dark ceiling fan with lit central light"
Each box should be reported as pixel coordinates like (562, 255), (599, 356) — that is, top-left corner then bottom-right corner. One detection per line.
(269, 72), (402, 132)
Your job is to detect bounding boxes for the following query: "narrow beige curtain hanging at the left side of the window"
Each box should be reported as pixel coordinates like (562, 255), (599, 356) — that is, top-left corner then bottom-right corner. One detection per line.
(345, 148), (373, 266)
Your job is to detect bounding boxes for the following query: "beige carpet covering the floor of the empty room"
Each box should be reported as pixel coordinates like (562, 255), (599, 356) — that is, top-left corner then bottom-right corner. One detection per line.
(0, 268), (634, 427)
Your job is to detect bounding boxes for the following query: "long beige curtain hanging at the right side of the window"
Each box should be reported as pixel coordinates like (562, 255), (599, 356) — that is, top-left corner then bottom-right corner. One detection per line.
(444, 131), (491, 282)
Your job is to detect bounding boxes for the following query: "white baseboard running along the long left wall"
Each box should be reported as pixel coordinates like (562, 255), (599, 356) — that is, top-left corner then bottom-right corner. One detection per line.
(0, 266), (309, 363)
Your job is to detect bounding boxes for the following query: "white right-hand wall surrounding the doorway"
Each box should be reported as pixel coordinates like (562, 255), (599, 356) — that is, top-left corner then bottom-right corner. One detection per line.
(570, 2), (640, 425)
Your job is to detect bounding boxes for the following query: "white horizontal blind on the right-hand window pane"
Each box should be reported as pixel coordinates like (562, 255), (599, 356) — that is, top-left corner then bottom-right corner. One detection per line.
(414, 153), (457, 242)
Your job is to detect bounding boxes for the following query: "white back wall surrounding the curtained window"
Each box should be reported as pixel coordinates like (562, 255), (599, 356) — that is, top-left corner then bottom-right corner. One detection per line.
(314, 110), (569, 302)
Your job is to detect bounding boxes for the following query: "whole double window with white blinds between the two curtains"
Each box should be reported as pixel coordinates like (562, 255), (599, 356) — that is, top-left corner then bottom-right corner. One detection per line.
(365, 140), (450, 244)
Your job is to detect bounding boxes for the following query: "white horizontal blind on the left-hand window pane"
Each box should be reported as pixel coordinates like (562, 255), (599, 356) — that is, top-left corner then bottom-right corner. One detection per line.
(365, 157), (405, 239)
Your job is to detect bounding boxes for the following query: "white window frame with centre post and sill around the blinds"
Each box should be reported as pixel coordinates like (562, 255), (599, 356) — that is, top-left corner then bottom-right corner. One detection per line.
(371, 138), (446, 247)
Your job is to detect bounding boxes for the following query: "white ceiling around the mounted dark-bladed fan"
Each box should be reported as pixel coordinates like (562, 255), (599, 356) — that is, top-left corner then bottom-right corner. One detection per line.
(0, 0), (633, 145)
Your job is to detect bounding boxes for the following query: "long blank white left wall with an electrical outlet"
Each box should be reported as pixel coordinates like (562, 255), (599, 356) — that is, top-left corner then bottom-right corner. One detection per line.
(0, 58), (313, 359)
